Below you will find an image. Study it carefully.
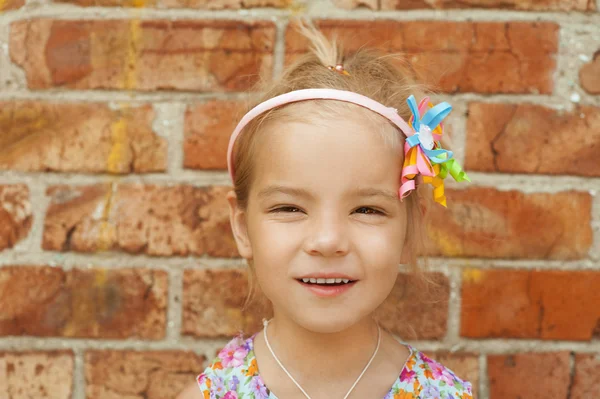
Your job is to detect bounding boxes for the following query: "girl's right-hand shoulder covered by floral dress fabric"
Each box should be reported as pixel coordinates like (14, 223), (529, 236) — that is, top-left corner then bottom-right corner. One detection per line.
(392, 345), (473, 399)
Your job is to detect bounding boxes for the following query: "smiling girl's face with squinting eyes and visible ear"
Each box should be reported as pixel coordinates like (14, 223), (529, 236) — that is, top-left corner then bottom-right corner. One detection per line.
(230, 108), (407, 333)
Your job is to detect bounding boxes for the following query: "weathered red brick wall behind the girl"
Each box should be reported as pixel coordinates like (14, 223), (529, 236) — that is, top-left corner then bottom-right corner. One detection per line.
(0, 0), (600, 399)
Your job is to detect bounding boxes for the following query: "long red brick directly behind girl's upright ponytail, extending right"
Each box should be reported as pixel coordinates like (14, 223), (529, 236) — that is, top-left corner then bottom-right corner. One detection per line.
(286, 20), (559, 94)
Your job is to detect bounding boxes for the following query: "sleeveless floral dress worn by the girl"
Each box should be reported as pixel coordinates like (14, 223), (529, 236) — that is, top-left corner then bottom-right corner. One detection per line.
(197, 334), (473, 399)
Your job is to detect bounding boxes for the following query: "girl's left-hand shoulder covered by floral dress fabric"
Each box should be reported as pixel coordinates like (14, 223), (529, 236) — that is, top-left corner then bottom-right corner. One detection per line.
(196, 334), (269, 399)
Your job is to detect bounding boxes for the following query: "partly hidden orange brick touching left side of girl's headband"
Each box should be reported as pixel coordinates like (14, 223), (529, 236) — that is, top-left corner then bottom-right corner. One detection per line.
(183, 100), (245, 169)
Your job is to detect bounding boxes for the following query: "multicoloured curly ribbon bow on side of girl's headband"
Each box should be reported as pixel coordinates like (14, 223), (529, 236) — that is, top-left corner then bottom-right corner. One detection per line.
(400, 95), (471, 206)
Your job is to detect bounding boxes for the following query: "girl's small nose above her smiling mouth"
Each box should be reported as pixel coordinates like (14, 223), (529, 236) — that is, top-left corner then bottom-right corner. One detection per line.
(305, 214), (350, 256)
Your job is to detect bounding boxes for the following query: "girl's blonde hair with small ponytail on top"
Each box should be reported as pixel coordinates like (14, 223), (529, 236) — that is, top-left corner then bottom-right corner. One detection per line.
(233, 23), (440, 328)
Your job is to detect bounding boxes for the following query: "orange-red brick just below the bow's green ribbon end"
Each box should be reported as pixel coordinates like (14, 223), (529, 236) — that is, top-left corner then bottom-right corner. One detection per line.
(428, 187), (592, 259)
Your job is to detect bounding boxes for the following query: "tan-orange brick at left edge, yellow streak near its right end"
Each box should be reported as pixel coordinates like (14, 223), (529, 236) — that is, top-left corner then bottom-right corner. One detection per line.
(0, 101), (167, 173)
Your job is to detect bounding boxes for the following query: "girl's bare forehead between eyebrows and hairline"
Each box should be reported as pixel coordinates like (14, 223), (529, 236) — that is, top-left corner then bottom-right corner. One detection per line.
(254, 118), (402, 195)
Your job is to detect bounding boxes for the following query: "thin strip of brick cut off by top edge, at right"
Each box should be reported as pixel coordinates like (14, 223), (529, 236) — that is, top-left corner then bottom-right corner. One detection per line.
(333, 0), (596, 11)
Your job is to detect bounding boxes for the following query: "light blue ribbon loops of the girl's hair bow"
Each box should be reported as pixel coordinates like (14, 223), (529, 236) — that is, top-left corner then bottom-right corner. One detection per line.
(406, 95), (453, 164)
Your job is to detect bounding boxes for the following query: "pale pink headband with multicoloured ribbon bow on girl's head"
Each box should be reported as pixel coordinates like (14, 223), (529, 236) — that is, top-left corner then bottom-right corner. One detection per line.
(227, 89), (468, 206)
